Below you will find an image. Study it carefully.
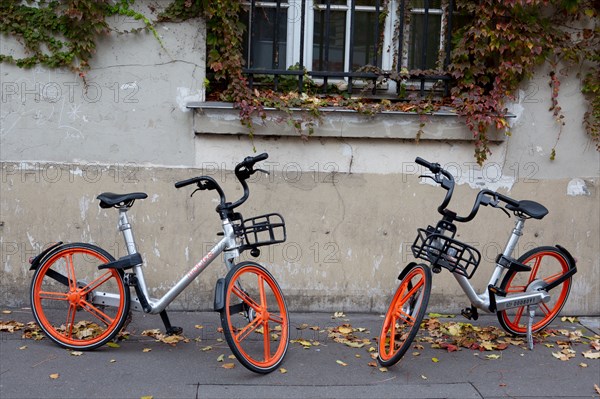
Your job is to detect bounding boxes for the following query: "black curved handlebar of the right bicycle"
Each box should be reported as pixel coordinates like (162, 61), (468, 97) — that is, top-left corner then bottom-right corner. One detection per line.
(415, 157), (519, 223)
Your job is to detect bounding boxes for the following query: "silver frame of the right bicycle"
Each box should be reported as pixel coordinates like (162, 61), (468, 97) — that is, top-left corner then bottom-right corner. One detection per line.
(452, 216), (550, 313)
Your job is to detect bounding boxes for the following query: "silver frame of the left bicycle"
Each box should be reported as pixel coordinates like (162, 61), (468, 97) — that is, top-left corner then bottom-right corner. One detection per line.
(92, 208), (239, 314)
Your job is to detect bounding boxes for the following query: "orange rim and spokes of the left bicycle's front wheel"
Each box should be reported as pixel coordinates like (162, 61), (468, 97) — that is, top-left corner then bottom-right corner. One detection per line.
(225, 266), (288, 368)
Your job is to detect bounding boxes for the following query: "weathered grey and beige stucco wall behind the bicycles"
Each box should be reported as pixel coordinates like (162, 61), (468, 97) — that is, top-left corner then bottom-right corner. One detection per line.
(0, 2), (600, 314)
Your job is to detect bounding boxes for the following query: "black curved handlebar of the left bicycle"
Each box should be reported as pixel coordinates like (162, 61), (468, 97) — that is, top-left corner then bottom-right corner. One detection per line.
(175, 152), (269, 216)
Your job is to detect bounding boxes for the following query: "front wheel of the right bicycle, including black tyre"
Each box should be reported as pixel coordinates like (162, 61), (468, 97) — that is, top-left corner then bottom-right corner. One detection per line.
(377, 264), (432, 367)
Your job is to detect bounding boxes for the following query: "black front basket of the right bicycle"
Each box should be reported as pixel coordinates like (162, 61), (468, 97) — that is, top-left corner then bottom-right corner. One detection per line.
(411, 223), (481, 278)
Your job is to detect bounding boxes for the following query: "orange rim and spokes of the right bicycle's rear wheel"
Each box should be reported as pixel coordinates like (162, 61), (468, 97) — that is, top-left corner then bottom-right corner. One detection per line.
(503, 251), (571, 333)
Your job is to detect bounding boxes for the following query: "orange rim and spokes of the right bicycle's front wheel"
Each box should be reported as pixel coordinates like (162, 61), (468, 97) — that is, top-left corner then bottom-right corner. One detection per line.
(379, 268), (425, 361)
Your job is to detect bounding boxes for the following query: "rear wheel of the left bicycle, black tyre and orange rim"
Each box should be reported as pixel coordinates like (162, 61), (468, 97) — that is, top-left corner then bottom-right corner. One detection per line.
(30, 243), (130, 350)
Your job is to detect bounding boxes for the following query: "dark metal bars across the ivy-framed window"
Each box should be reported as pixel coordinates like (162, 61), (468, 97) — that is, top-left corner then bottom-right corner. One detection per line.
(244, 0), (455, 96)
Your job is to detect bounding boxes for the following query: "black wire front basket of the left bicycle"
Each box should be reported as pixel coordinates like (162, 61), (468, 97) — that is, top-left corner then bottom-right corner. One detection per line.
(240, 213), (286, 248)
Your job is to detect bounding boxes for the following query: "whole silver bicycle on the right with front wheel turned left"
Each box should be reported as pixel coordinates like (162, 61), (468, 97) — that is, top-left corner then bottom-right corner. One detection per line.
(378, 158), (577, 366)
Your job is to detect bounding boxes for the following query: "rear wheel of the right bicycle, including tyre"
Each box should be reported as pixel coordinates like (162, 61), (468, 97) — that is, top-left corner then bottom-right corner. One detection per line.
(497, 247), (574, 335)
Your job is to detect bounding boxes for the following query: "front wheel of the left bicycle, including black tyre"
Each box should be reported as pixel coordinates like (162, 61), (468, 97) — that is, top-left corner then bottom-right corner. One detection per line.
(221, 262), (289, 374)
